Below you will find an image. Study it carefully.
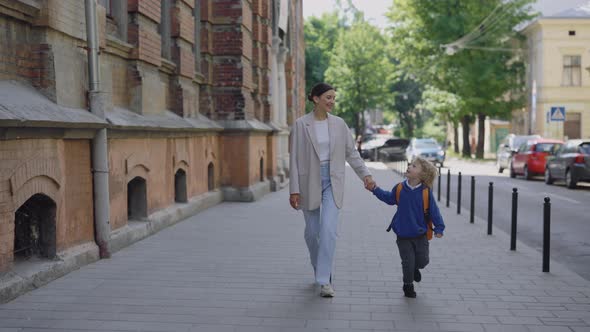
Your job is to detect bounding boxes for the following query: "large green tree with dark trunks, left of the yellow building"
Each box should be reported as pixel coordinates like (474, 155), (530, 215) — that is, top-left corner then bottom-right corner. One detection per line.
(388, 0), (534, 157)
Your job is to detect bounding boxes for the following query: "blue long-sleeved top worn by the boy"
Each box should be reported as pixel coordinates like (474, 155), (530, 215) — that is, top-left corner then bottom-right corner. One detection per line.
(373, 181), (445, 238)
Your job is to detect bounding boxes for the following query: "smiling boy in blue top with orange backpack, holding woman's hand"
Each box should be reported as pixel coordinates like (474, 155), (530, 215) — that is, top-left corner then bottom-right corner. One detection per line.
(367, 157), (445, 298)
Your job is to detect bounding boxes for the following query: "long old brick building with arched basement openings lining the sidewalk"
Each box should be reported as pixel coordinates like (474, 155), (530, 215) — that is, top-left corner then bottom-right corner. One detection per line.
(0, 0), (305, 300)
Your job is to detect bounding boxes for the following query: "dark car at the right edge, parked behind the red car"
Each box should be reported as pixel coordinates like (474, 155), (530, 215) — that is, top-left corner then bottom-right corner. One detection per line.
(545, 139), (590, 188)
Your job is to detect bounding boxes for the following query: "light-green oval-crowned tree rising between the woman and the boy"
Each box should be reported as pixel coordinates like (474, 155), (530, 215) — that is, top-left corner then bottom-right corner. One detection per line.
(325, 20), (392, 145)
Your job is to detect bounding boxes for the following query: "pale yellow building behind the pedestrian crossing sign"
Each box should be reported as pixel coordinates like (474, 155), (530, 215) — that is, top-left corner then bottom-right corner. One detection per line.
(524, 3), (590, 139)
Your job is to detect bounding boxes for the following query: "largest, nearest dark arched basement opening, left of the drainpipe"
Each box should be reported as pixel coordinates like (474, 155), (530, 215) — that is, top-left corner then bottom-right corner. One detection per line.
(14, 194), (57, 260)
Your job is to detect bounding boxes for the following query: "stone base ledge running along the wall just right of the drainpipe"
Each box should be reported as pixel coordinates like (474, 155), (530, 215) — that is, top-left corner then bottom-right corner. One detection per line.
(109, 190), (222, 253)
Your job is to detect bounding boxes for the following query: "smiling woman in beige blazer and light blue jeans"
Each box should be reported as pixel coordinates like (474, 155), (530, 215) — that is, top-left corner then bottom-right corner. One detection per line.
(289, 83), (374, 297)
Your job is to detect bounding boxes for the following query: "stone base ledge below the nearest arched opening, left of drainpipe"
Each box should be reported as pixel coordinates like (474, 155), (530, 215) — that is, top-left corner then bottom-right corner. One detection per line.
(0, 242), (99, 303)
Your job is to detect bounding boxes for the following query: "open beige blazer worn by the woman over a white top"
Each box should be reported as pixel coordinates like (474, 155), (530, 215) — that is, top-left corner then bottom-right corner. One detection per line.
(289, 112), (371, 210)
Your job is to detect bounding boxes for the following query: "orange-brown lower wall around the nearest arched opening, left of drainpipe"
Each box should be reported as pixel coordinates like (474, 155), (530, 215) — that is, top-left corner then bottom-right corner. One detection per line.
(0, 139), (94, 271)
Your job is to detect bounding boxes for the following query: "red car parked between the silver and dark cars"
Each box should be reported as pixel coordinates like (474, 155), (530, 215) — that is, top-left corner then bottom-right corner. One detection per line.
(510, 138), (563, 180)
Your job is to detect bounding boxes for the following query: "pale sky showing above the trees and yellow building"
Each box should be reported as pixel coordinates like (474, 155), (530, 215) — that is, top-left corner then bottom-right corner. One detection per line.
(303, 0), (590, 28)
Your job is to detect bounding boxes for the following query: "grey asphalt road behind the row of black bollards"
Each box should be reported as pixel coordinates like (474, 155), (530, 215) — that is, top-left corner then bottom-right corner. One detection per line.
(388, 160), (590, 280)
